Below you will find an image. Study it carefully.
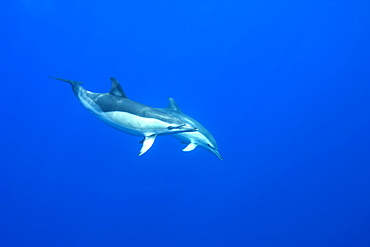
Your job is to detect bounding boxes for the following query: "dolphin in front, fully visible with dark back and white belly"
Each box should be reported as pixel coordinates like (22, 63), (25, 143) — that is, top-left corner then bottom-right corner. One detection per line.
(50, 76), (196, 156)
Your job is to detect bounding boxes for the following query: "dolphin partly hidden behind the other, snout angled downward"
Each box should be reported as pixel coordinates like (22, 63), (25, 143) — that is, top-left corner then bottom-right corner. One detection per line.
(157, 98), (223, 160)
